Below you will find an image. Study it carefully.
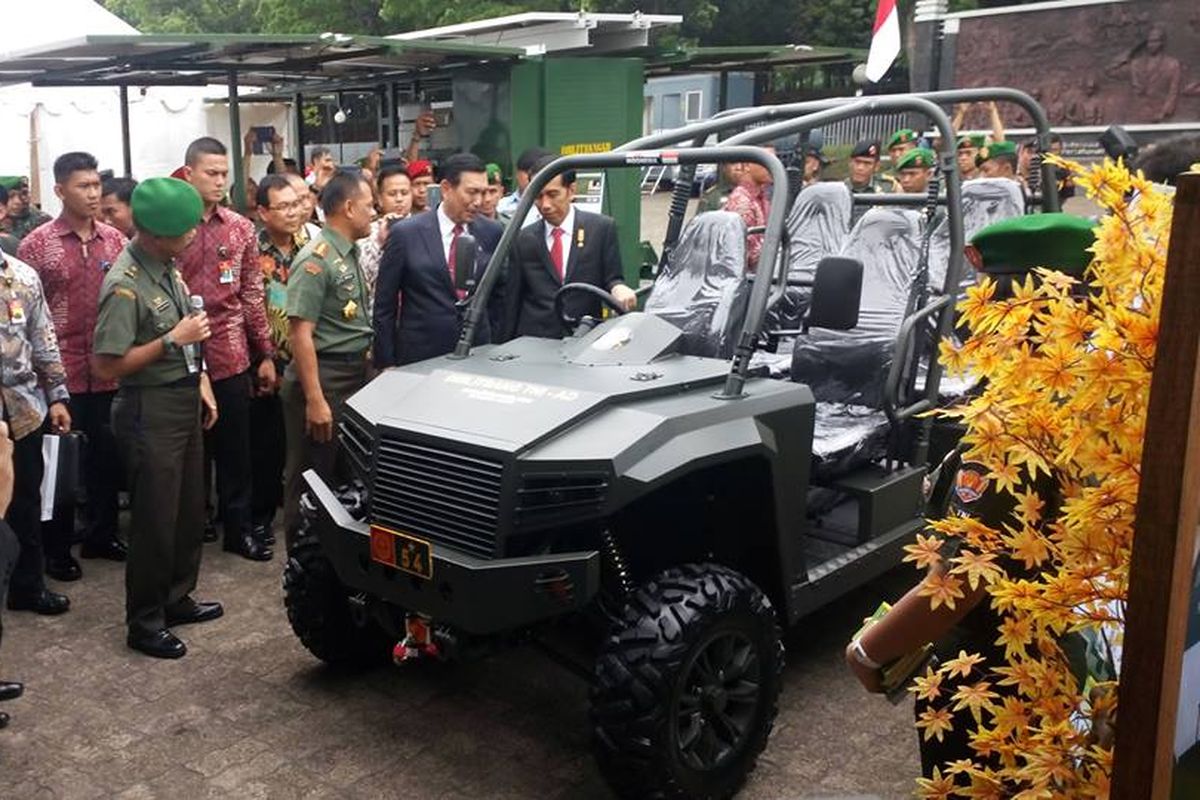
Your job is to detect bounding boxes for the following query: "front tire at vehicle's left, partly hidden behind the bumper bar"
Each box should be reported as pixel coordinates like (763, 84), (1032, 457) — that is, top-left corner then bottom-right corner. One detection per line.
(283, 501), (392, 667)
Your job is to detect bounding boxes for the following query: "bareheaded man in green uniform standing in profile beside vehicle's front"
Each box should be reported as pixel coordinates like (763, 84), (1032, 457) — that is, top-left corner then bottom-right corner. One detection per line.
(282, 165), (374, 546)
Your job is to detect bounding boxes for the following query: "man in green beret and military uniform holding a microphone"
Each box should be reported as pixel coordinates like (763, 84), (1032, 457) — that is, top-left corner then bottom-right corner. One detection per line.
(92, 178), (223, 658)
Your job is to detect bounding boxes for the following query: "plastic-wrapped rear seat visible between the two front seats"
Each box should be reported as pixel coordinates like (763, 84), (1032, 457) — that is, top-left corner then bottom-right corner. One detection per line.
(767, 181), (853, 330)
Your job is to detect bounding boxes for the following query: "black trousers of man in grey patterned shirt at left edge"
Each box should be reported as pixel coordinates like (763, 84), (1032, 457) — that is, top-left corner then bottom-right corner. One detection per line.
(5, 421), (46, 597)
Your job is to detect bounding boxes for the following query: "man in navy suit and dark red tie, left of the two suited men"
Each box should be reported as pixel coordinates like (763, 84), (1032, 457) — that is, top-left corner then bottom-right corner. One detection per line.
(373, 152), (503, 368)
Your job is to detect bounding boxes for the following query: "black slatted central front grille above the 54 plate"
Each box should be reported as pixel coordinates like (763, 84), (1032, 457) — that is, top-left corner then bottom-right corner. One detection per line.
(371, 434), (504, 558)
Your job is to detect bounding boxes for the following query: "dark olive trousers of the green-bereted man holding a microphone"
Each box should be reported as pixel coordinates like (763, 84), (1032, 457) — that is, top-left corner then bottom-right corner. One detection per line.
(113, 385), (204, 632)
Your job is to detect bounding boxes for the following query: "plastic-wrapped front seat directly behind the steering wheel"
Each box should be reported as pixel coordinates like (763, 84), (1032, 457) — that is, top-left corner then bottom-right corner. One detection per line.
(646, 211), (749, 357)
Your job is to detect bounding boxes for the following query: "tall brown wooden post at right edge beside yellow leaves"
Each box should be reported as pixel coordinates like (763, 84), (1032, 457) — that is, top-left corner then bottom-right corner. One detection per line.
(1112, 167), (1200, 800)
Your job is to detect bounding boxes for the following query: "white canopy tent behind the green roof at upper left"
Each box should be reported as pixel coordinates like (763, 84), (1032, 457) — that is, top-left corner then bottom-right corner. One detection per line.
(0, 0), (292, 213)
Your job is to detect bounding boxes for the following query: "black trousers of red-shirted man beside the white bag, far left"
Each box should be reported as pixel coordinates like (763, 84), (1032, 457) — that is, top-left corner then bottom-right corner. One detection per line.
(42, 392), (121, 558)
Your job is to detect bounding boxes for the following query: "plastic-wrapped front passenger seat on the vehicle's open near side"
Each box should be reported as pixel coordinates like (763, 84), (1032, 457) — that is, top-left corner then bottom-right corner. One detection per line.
(792, 207), (920, 477)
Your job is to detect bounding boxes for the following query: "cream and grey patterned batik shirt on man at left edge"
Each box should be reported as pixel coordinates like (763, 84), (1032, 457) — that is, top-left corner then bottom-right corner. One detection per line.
(0, 257), (70, 439)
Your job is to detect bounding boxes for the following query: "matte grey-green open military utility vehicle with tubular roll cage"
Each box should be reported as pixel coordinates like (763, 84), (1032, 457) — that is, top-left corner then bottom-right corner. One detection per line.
(284, 97), (1041, 798)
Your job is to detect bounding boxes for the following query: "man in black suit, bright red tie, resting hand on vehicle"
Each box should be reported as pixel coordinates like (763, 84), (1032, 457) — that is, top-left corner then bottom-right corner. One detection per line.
(498, 156), (637, 341)
